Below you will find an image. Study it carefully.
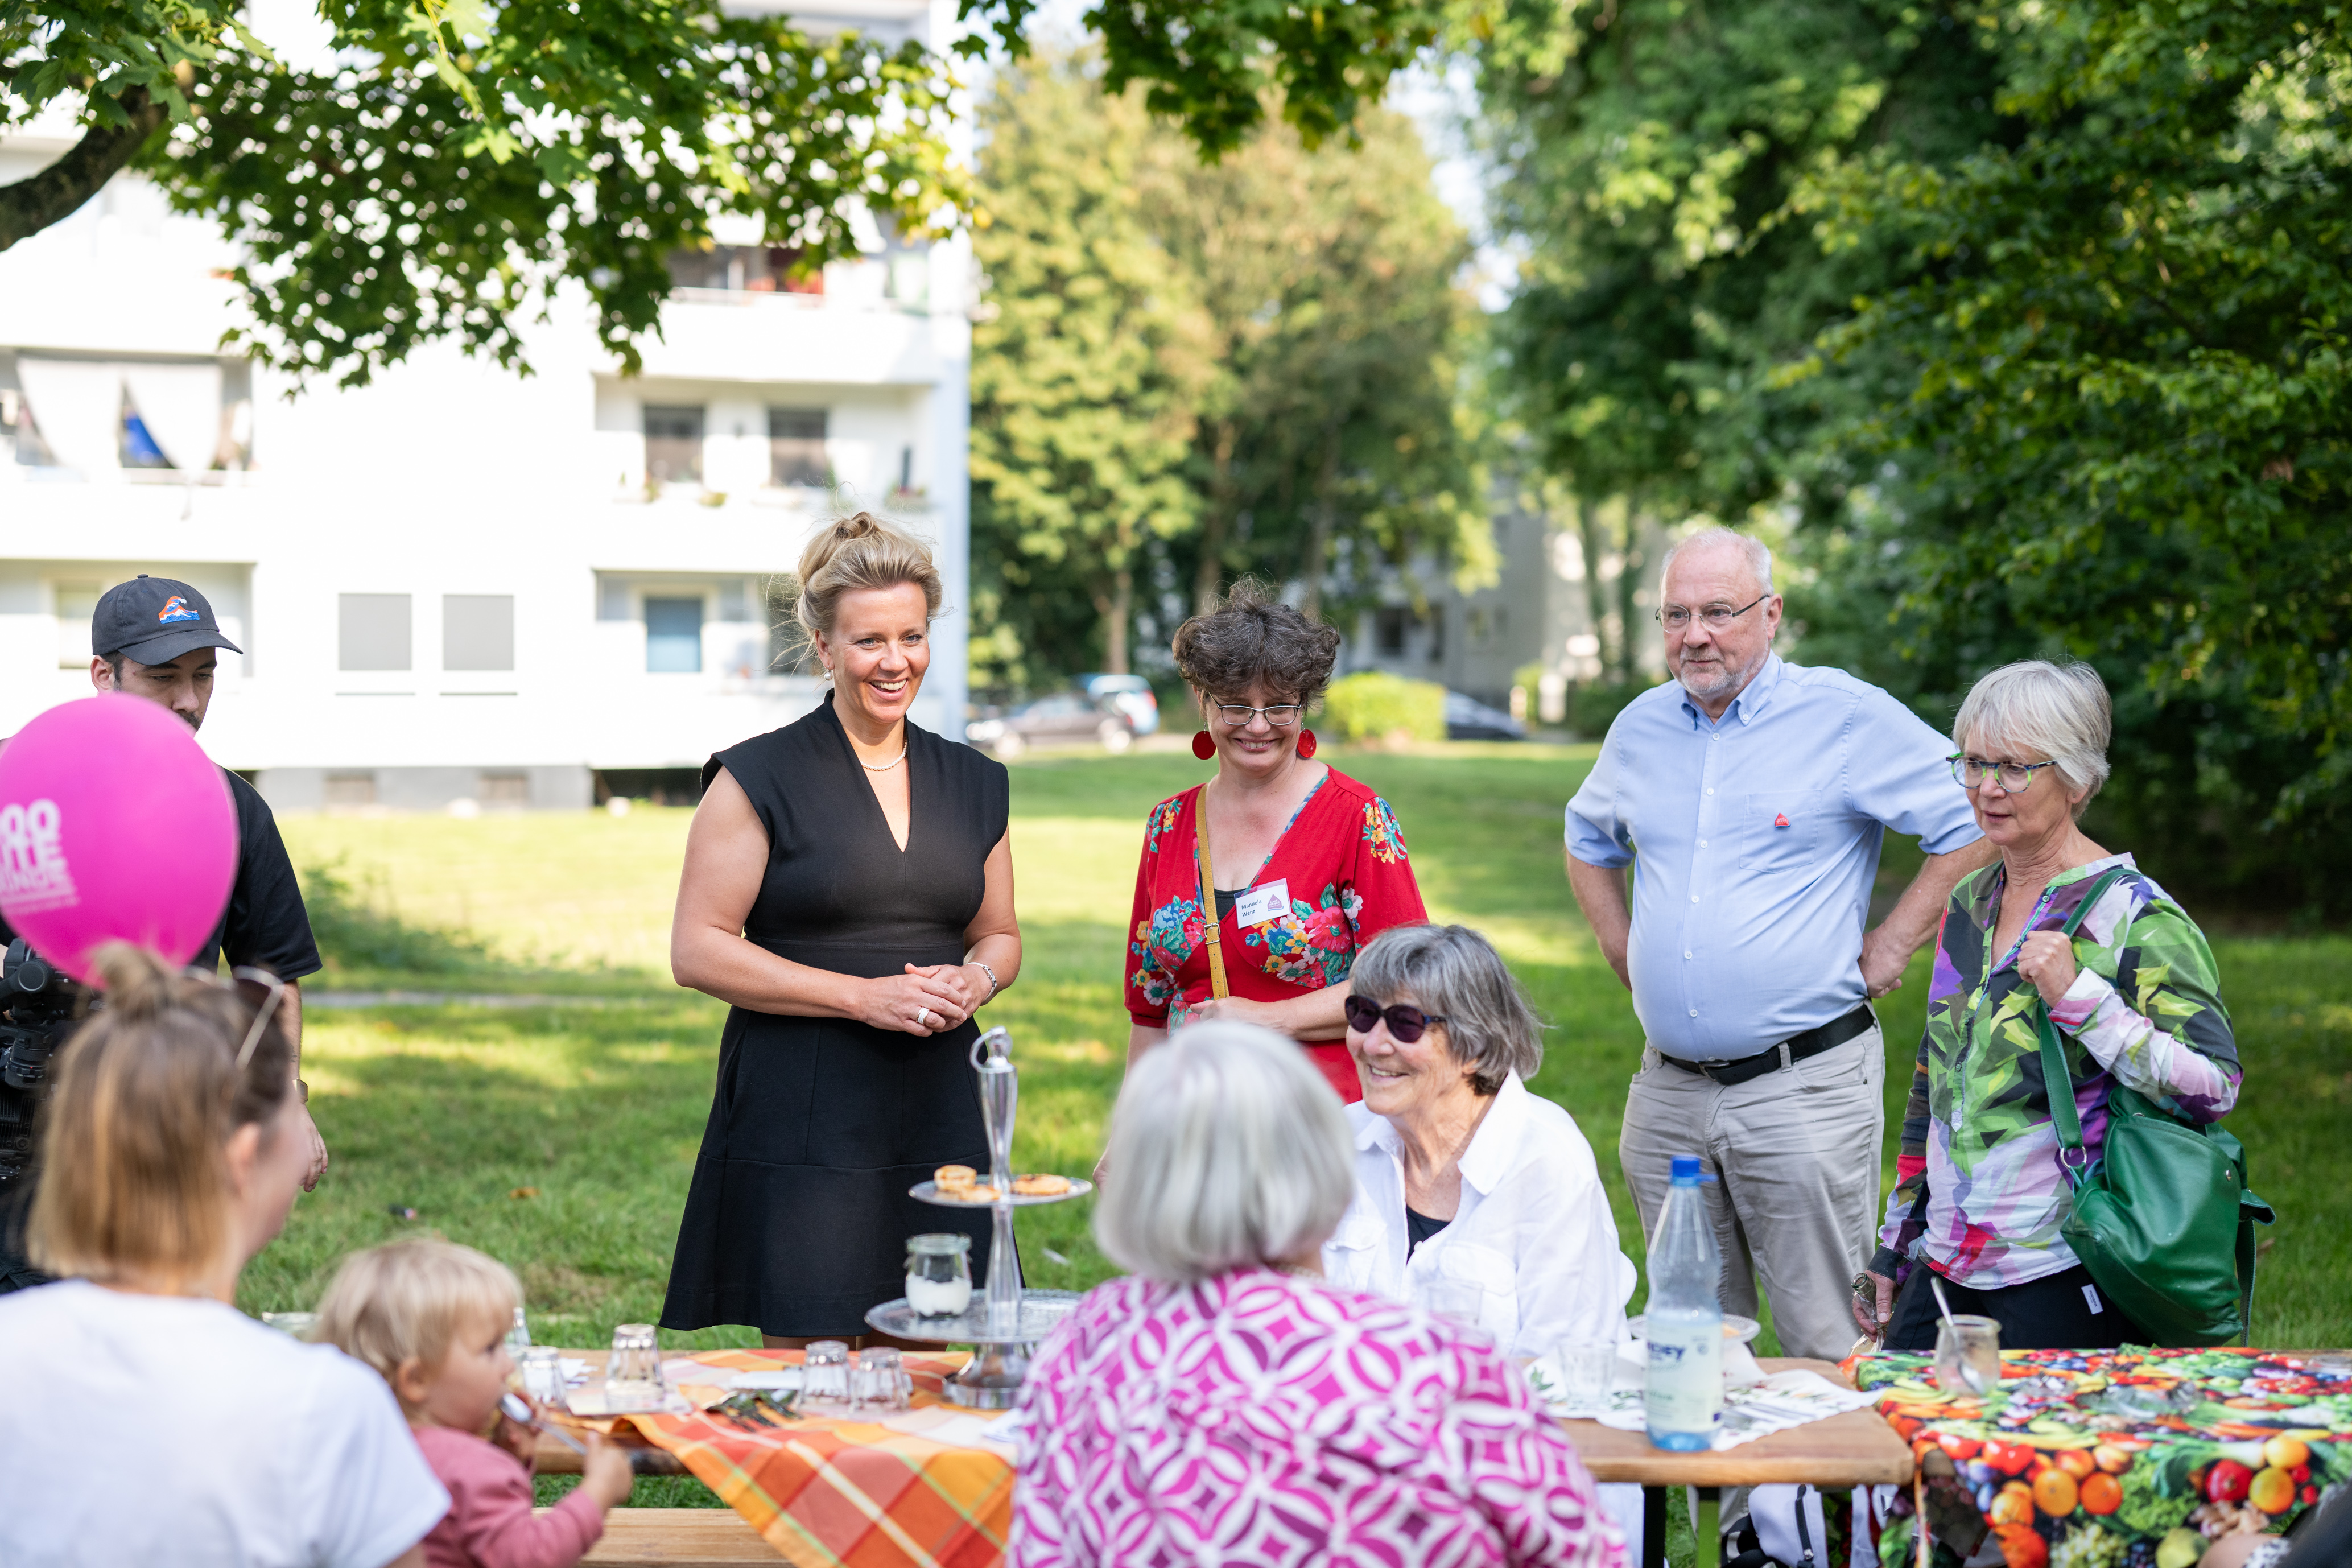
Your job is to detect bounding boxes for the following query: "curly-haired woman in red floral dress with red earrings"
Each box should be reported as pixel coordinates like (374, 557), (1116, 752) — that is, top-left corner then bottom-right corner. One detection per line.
(1127, 581), (1427, 1103)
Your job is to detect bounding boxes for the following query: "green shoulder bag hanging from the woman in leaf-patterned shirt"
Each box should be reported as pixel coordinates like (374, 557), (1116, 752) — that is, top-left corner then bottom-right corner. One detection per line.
(2041, 865), (2277, 1344)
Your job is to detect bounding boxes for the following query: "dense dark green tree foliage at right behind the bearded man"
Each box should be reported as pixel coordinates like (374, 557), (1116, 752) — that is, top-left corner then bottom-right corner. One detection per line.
(1477, 0), (2352, 903)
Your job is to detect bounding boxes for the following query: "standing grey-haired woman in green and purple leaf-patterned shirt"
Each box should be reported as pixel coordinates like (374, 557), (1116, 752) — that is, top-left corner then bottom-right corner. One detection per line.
(1856, 661), (2239, 1350)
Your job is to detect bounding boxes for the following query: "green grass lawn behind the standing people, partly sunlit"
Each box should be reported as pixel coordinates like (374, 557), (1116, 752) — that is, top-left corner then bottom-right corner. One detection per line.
(257, 745), (2352, 1344)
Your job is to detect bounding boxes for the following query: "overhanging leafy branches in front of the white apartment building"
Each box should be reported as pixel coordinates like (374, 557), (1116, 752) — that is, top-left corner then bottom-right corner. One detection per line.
(0, 0), (962, 386)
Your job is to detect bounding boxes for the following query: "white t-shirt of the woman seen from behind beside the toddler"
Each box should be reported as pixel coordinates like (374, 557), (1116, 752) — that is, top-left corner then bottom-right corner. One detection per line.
(0, 1279), (449, 1568)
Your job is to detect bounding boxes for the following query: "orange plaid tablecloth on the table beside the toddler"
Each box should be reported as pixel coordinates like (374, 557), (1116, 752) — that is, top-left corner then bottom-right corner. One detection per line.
(597, 1350), (1014, 1568)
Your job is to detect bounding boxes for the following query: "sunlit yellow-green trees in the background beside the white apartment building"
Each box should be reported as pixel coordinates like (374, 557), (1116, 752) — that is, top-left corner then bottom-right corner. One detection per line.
(973, 54), (1491, 684)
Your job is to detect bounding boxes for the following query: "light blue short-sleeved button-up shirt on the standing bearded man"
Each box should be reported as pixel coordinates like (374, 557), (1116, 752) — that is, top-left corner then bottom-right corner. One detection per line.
(1566, 654), (1980, 1063)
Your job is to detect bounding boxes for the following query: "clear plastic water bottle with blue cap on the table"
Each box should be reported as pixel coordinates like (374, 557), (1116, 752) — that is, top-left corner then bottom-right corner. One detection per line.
(1642, 1154), (1724, 1453)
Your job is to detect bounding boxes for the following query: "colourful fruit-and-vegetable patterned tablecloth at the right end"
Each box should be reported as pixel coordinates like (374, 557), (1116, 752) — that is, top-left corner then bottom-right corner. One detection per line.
(1844, 1347), (2352, 1568)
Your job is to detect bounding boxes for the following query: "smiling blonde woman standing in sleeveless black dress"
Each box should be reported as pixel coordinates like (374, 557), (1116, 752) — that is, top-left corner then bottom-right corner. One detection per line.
(661, 513), (1021, 1344)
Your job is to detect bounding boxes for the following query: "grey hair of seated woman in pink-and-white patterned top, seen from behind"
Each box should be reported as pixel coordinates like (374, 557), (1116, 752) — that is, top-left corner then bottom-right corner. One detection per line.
(1094, 1022), (1355, 1284)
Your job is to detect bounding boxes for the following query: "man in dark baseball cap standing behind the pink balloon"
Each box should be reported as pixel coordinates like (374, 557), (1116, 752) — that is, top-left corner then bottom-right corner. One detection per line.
(0, 573), (327, 1203)
